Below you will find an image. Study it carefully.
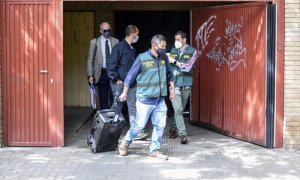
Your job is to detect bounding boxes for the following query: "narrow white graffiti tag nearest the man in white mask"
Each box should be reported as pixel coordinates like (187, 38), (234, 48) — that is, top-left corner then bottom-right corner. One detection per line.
(195, 16), (217, 56)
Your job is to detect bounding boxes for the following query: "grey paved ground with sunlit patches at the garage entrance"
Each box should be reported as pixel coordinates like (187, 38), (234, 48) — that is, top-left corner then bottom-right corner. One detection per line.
(0, 107), (300, 180)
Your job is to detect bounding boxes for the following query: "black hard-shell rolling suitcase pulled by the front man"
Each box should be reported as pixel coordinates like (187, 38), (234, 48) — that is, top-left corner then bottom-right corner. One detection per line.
(87, 109), (125, 153)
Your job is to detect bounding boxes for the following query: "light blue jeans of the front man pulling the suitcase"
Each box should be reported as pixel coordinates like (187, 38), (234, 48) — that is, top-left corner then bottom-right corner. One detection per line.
(124, 98), (167, 153)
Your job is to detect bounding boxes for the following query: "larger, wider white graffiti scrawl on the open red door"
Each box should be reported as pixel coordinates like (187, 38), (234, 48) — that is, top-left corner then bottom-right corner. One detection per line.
(206, 17), (246, 71)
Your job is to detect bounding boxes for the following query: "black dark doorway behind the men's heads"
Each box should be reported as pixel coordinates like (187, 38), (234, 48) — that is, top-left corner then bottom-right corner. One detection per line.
(115, 11), (190, 54)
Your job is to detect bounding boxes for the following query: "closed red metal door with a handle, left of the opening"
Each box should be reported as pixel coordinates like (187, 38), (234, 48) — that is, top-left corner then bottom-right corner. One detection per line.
(1, 0), (63, 146)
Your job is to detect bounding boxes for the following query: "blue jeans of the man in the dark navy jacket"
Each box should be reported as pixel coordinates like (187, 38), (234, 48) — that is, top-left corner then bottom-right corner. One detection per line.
(110, 82), (136, 125)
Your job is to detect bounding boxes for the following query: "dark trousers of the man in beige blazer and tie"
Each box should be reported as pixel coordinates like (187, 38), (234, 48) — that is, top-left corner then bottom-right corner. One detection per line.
(97, 71), (113, 110)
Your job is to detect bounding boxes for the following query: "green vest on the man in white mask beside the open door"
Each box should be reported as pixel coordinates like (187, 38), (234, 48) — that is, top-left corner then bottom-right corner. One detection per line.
(170, 46), (195, 87)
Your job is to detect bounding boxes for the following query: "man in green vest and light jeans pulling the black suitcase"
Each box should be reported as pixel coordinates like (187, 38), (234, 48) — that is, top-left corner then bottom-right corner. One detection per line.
(119, 35), (175, 160)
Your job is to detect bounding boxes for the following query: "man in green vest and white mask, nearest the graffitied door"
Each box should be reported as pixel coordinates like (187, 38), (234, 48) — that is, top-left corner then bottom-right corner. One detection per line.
(169, 31), (198, 144)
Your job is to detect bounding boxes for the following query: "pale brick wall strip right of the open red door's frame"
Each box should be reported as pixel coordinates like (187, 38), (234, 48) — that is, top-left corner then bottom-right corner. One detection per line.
(283, 0), (300, 149)
